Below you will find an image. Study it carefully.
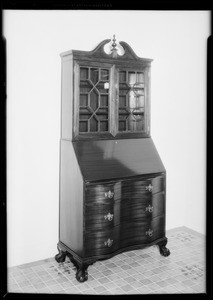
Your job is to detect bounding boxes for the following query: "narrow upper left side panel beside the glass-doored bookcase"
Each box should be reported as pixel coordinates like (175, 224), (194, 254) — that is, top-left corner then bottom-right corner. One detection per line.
(61, 56), (73, 140)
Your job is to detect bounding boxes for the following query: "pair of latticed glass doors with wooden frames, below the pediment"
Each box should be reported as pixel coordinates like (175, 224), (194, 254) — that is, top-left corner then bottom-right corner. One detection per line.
(74, 63), (148, 139)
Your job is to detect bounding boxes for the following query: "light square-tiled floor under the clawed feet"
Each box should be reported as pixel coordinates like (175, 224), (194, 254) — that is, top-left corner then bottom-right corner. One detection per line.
(8, 227), (205, 295)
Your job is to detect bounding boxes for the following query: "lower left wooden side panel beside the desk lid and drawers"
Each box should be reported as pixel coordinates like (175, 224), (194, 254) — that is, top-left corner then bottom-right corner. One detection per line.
(59, 140), (83, 256)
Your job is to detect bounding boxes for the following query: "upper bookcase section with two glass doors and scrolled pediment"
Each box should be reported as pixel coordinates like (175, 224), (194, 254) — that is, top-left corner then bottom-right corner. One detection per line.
(61, 38), (152, 140)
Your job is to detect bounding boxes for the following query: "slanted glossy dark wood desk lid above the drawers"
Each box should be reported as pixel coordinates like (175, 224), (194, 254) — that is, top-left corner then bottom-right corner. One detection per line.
(72, 138), (165, 181)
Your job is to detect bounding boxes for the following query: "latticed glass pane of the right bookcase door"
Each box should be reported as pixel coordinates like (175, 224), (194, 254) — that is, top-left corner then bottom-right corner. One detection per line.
(118, 70), (145, 132)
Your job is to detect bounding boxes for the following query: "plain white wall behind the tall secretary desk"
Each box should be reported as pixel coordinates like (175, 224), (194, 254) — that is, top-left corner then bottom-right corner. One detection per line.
(3, 10), (210, 267)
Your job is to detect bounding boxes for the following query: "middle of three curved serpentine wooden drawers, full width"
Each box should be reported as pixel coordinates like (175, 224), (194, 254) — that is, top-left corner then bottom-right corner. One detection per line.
(85, 192), (165, 231)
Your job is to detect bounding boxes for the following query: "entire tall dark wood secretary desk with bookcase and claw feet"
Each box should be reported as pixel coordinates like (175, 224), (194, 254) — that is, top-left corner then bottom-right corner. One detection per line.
(55, 37), (170, 282)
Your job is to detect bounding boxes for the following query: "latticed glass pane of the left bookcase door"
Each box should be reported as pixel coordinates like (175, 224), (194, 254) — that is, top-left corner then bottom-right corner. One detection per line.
(79, 66), (110, 133)
